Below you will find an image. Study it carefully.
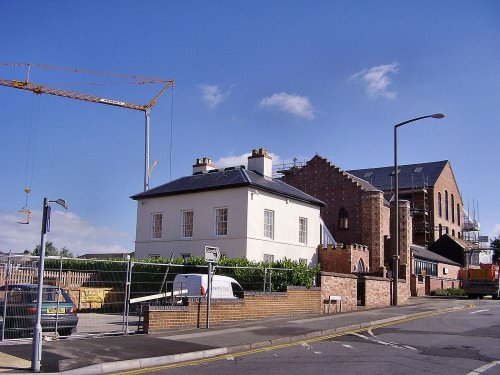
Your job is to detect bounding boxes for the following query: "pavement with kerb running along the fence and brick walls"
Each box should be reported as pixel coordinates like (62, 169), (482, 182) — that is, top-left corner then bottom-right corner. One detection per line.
(0, 297), (470, 375)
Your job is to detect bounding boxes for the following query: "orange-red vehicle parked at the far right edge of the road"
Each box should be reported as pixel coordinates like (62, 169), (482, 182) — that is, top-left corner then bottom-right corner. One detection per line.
(459, 264), (500, 299)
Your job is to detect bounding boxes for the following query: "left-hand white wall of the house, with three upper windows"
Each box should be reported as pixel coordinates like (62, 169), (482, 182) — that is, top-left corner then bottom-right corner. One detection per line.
(135, 187), (248, 258)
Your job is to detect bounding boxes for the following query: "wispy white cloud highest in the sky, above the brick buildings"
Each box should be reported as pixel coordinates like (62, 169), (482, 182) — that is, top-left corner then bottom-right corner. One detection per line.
(350, 63), (399, 99)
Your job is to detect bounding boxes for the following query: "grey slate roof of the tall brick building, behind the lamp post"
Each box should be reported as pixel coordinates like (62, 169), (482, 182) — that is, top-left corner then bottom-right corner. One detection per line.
(347, 160), (448, 191)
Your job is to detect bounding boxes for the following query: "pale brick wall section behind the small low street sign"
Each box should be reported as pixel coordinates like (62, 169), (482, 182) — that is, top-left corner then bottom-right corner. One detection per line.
(320, 272), (358, 313)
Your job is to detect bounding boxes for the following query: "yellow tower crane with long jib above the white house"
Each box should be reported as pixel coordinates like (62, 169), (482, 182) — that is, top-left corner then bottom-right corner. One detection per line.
(0, 64), (174, 191)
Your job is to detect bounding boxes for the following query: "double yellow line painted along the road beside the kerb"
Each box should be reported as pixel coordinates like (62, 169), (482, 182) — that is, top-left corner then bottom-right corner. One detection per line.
(116, 304), (476, 375)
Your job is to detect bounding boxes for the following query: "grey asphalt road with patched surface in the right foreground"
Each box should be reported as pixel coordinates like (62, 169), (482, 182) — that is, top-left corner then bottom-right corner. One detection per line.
(131, 300), (500, 375)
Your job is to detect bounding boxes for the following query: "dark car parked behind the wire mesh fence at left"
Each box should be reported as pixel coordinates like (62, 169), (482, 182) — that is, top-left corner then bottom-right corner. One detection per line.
(0, 284), (78, 338)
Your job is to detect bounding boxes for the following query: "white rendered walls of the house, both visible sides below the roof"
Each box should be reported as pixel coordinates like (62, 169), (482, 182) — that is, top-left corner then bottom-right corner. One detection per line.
(135, 187), (320, 265)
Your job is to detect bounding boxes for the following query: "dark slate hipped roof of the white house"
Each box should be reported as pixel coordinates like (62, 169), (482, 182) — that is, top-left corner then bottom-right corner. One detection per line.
(131, 167), (325, 207)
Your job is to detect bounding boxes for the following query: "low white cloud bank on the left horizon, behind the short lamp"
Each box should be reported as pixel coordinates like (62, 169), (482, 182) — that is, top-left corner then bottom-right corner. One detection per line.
(0, 209), (133, 255)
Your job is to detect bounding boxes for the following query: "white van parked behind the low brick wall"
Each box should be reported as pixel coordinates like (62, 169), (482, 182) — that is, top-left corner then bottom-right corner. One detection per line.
(173, 273), (244, 299)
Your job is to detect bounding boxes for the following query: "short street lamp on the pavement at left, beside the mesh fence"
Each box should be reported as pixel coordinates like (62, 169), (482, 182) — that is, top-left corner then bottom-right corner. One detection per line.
(31, 198), (68, 372)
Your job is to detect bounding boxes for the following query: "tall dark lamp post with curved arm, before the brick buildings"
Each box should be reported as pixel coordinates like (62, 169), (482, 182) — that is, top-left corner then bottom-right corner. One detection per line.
(392, 113), (444, 306)
